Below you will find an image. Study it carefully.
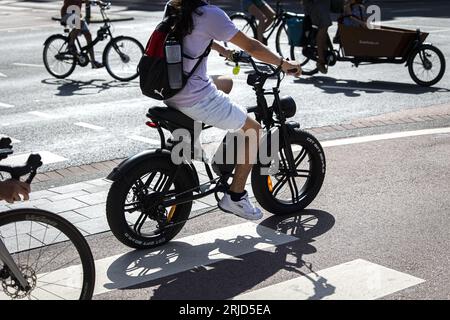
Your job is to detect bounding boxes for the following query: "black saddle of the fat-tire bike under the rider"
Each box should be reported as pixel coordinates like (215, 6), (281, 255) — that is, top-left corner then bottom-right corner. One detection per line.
(147, 106), (198, 132)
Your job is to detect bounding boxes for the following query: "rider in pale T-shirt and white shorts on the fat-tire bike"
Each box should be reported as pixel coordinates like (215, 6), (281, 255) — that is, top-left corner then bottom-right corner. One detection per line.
(164, 0), (301, 220)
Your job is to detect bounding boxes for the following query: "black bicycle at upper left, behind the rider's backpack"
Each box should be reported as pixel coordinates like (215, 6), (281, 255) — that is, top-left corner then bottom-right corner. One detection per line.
(43, 1), (144, 81)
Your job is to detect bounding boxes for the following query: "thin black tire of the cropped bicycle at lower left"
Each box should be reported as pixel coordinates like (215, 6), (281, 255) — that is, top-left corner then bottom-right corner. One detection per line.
(0, 209), (95, 300)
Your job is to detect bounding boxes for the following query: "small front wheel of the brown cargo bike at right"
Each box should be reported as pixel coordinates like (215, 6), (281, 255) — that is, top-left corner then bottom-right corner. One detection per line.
(408, 44), (445, 87)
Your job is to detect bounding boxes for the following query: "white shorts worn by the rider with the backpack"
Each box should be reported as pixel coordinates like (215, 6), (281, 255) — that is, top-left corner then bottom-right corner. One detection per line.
(175, 90), (247, 131)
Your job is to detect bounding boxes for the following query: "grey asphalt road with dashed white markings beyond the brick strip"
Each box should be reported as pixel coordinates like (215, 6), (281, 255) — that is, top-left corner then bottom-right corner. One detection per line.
(0, 1), (450, 169)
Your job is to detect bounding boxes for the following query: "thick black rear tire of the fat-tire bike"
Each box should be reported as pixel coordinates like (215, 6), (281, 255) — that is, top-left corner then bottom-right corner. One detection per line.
(106, 157), (192, 249)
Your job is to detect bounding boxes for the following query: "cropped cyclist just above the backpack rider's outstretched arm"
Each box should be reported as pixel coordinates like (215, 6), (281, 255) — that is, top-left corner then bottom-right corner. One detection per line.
(242, 0), (276, 45)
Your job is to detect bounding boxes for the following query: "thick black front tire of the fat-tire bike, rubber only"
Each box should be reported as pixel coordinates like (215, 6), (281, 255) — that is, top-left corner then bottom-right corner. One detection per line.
(251, 129), (326, 215)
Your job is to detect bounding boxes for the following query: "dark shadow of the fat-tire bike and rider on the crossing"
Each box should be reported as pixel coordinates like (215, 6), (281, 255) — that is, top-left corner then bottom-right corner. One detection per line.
(105, 210), (335, 300)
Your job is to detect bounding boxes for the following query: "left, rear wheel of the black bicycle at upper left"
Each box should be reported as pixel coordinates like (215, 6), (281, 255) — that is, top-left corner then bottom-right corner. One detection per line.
(43, 34), (77, 79)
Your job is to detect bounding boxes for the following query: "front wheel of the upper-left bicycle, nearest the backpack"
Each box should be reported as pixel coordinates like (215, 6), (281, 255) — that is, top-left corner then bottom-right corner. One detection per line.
(103, 36), (144, 81)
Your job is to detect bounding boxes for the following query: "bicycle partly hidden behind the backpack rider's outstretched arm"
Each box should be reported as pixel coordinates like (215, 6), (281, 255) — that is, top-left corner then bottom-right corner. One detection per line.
(224, 1), (298, 58)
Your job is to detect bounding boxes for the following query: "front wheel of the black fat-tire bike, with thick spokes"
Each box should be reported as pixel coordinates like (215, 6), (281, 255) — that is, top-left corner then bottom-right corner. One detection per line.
(252, 129), (326, 214)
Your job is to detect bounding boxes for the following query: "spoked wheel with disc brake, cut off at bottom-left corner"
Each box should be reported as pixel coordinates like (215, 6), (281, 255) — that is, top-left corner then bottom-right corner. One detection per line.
(0, 209), (95, 300)
